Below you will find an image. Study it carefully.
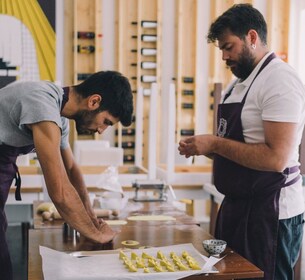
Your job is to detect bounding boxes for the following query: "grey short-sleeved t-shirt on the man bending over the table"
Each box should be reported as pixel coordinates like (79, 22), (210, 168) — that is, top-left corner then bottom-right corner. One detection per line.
(0, 81), (69, 149)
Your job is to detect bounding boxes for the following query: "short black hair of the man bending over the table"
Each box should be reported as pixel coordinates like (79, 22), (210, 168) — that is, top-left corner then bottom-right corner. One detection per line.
(74, 71), (133, 126)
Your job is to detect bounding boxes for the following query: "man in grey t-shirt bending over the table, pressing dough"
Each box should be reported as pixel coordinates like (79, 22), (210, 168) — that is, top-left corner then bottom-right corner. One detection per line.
(0, 71), (133, 280)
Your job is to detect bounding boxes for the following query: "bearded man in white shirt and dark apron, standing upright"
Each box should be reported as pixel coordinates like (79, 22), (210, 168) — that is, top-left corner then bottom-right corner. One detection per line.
(179, 4), (305, 280)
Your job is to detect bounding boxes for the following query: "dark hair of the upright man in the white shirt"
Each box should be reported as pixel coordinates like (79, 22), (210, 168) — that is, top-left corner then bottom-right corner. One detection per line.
(207, 4), (267, 45)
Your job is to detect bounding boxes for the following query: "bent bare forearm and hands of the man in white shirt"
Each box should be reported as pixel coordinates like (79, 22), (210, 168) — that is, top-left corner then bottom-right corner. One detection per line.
(179, 121), (297, 172)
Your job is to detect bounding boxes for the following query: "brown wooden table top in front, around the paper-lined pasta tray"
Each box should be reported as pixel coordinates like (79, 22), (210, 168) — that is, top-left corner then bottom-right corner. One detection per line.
(28, 225), (263, 280)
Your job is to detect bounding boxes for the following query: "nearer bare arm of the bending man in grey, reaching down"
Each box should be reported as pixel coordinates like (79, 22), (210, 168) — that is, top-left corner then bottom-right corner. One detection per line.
(31, 122), (114, 243)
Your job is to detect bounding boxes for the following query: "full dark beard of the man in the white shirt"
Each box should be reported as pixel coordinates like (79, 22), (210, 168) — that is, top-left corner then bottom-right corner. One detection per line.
(226, 45), (255, 80)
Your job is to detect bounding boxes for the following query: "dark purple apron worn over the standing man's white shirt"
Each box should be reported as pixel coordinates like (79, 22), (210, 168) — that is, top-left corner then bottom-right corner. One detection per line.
(213, 54), (300, 280)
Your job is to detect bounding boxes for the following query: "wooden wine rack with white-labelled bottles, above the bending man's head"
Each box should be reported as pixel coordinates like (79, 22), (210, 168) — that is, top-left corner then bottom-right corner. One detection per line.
(116, 0), (162, 167)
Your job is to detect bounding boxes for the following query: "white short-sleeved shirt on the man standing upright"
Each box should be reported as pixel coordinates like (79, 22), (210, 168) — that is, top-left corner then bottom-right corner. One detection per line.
(223, 53), (305, 219)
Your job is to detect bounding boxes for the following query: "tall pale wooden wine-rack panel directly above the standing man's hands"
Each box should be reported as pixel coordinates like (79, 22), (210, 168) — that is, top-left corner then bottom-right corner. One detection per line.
(176, 0), (197, 143)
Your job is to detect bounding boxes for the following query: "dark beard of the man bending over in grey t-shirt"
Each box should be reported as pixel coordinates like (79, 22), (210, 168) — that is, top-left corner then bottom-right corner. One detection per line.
(72, 110), (98, 135)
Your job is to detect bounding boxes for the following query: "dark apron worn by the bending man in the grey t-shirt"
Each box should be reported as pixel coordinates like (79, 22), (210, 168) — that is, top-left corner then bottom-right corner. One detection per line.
(0, 87), (69, 280)
